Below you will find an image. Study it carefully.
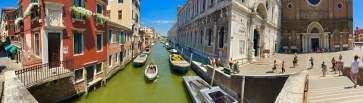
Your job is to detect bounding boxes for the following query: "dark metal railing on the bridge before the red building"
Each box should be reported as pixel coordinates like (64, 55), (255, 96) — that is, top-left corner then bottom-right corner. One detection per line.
(15, 62), (71, 87)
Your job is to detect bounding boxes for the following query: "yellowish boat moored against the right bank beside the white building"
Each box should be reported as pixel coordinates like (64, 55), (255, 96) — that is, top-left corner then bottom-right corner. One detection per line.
(169, 54), (190, 74)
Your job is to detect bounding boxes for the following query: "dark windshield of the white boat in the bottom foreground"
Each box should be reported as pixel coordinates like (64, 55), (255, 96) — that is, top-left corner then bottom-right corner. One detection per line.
(208, 91), (235, 103)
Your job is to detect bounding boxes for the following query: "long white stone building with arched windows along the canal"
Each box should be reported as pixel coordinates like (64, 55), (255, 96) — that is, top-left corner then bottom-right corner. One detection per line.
(176, 0), (281, 64)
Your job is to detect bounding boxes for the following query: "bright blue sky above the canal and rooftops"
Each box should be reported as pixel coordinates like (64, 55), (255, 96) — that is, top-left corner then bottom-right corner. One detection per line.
(0, 0), (363, 35)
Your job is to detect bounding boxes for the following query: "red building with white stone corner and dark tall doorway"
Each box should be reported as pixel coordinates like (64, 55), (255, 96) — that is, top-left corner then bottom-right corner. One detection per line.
(18, 0), (109, 93)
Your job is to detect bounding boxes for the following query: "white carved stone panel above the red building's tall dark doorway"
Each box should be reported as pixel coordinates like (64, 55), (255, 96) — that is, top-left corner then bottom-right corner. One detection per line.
(45, 4), (64, 28)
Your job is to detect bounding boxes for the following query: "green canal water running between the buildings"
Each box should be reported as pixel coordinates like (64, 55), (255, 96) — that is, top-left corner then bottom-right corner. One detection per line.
(72, 43), (196, 103)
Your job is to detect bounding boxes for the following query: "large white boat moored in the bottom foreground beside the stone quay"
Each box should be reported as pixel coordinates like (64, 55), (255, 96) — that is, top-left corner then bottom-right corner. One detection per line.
(183, 76), (238, 103)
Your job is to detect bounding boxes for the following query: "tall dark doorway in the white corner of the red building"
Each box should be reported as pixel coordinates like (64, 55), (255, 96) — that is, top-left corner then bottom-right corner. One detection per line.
(48, 33), (61, 68)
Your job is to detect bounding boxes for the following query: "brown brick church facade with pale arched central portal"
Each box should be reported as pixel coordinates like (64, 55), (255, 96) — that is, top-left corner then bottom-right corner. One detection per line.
(280, 0), (353, 52)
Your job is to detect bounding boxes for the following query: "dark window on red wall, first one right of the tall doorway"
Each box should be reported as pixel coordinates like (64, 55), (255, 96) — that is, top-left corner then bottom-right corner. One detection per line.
(73, 32), (83, 54)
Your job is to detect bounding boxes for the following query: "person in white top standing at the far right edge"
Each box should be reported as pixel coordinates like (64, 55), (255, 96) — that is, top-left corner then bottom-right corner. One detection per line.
(350, 55), (360, 88)
